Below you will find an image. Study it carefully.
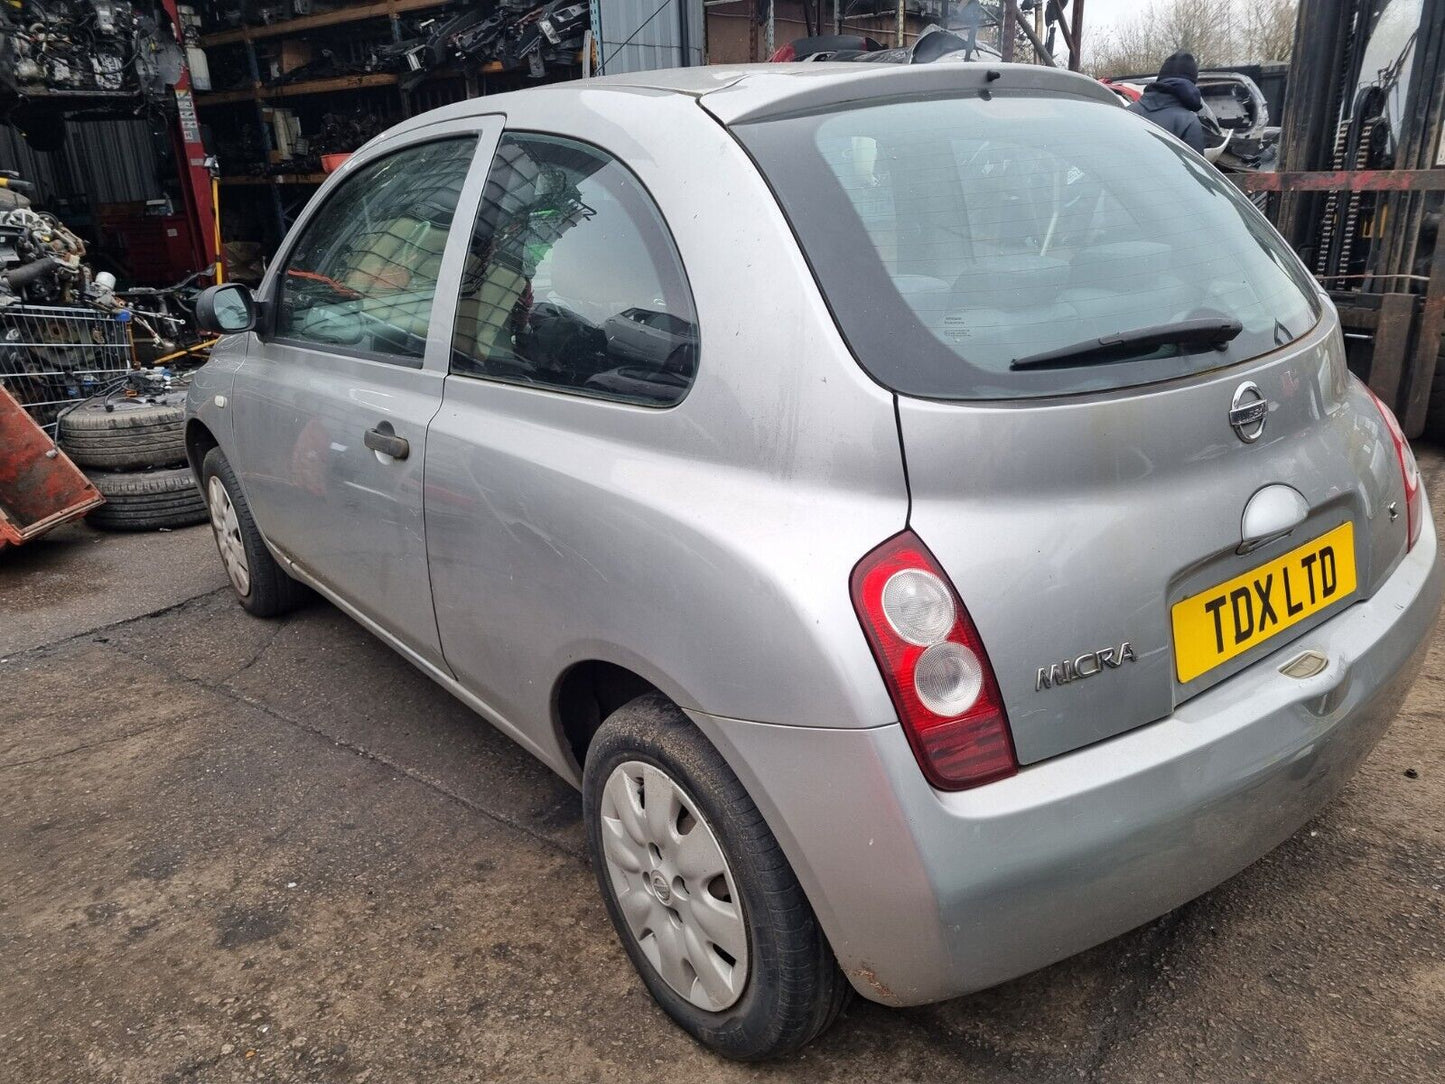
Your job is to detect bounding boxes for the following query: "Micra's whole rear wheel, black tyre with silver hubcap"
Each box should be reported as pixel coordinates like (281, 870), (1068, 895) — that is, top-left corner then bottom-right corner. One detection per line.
(582, 694), (851, 1061)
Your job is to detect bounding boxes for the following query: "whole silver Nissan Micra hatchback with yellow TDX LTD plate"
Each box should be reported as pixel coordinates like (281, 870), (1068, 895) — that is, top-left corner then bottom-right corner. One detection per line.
(186, 64), (1442, 1058)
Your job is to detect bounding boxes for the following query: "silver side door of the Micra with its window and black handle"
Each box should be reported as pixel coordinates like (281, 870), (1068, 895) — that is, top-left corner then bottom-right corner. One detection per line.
(233, 119), (500, 668)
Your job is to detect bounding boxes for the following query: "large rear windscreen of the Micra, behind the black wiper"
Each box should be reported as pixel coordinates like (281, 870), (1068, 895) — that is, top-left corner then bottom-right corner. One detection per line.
(736, 94), (1319, 399)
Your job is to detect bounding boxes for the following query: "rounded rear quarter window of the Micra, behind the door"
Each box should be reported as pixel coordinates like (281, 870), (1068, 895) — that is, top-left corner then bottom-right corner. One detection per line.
(451, 134), (698, 406)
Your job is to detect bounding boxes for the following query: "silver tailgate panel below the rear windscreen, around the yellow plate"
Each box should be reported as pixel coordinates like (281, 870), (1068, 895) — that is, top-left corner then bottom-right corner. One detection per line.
(899, 315), (1405, 763)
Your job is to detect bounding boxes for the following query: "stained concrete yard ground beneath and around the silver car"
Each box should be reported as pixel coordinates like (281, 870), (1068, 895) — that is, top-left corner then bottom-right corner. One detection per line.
(0, 451), (1445, 1084)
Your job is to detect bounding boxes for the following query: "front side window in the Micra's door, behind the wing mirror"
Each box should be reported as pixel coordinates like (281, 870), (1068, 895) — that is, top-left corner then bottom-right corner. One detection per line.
(275, 137), (475, 361)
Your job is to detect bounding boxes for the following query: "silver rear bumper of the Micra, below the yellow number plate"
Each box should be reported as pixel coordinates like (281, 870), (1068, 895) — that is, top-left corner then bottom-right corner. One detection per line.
(694, 517), (1445, 1005)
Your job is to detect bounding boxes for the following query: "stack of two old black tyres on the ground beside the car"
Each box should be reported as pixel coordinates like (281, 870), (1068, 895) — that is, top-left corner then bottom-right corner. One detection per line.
(58, 390), (207, 530)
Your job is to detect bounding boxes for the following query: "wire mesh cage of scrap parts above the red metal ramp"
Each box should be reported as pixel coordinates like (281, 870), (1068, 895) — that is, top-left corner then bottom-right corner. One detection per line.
(0, 305), (131, 435)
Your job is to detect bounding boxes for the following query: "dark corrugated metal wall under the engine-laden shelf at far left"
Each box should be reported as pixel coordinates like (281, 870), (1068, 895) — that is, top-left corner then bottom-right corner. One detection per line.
(0, 120), (165, 207)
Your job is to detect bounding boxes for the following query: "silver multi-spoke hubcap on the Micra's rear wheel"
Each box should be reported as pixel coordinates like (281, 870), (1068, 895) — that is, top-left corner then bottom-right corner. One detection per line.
(601, 760), (749, 1012)
